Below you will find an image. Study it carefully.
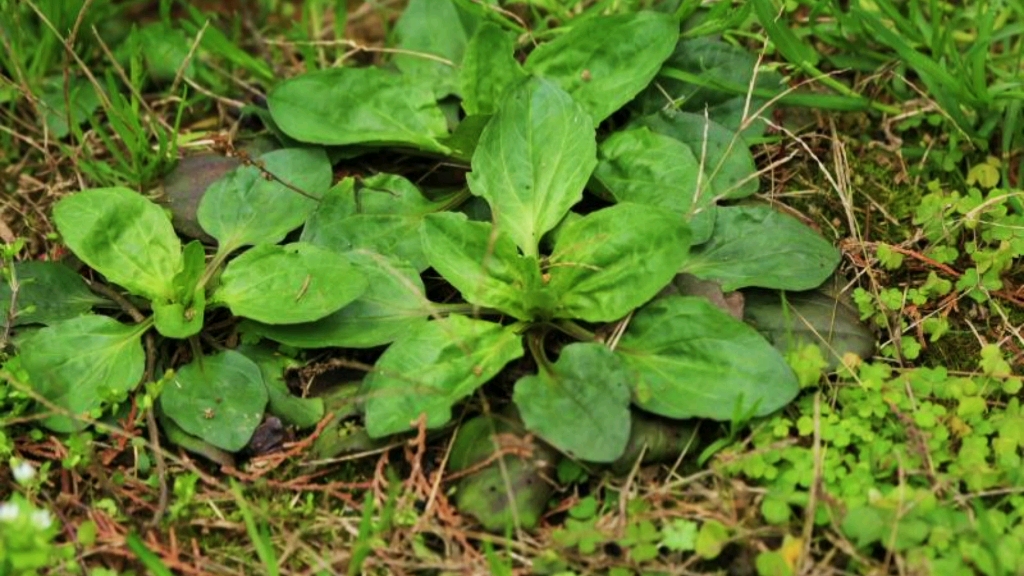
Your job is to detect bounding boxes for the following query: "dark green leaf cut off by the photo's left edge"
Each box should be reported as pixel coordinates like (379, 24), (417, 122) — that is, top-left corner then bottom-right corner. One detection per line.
(0, 260), (108, 327)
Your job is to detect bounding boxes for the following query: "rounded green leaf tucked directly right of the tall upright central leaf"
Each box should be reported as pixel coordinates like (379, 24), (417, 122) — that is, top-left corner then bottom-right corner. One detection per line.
(594, 127), (715, 244)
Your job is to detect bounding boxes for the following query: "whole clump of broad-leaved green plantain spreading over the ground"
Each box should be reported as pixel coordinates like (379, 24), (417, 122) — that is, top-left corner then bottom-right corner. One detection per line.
(6, 0), (840, 498)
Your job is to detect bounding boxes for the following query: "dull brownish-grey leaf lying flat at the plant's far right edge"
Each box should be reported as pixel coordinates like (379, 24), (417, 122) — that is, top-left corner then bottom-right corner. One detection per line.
(743, 290), (876, 370)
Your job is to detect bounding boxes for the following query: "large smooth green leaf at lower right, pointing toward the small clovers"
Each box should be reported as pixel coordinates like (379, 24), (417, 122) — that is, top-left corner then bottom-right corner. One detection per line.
(615, 296), (800, 420)
